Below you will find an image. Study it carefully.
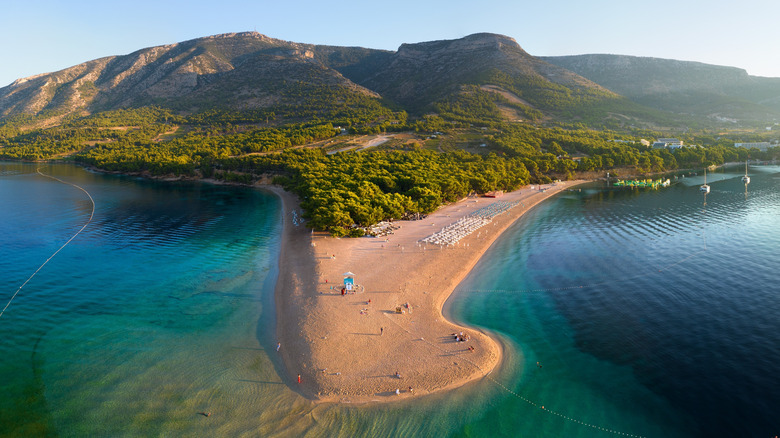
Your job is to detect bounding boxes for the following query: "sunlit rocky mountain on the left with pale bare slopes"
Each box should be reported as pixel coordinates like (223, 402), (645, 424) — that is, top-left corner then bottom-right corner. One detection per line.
(0, 32), (386, 121)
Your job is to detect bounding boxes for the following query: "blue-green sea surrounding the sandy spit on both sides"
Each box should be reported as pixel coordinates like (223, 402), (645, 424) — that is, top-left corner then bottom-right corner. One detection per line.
(0, 162), (780, 437)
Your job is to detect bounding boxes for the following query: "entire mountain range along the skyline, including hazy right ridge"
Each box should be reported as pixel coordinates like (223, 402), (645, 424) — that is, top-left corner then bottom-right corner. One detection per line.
(0, 32), (780, 127)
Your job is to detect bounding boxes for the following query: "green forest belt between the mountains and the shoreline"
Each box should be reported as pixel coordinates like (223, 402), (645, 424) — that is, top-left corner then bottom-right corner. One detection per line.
(0, 100), (780, 236)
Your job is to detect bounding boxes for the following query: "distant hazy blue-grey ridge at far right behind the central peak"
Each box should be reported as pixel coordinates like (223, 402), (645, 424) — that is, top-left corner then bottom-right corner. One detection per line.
(542, 55), (780, 121)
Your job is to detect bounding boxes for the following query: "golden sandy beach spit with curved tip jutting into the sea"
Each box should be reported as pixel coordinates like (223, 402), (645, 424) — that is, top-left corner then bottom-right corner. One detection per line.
(270, 181), (583, 403)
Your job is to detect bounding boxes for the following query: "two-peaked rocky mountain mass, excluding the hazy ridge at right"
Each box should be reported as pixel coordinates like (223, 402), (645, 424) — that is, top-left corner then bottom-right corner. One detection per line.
(0, 32), (644, 128)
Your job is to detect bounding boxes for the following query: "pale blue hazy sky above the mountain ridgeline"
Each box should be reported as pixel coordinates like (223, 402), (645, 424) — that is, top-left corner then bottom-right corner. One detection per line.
(0, 0), (780, 87)
